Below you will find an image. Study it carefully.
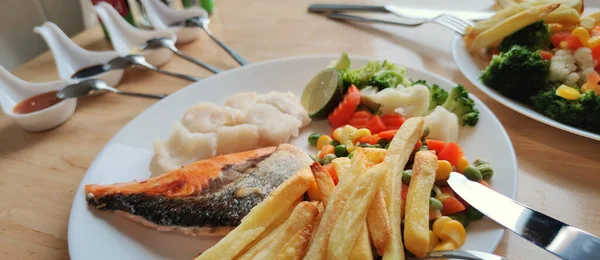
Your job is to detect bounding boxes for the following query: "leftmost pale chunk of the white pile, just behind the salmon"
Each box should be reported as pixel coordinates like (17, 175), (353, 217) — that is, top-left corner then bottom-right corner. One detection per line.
(154, 122), (217, 172)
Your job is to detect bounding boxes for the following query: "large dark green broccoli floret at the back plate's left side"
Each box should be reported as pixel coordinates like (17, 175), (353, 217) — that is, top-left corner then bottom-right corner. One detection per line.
(480, 46), (550, 102)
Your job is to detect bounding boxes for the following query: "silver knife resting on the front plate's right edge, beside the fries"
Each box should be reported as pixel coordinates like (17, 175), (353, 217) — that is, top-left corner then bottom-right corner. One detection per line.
(448, 172), (600, 260)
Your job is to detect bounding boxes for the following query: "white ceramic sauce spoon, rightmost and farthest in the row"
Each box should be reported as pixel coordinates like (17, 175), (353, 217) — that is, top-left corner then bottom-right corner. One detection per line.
(142, 0), (208, 44)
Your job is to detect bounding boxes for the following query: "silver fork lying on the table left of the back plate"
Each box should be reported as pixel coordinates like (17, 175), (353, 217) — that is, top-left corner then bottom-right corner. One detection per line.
(327, 13), (473, 35)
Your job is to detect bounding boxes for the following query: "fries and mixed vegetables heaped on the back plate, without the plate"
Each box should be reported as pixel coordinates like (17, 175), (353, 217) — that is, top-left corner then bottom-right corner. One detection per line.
(465, 0), (600, 133)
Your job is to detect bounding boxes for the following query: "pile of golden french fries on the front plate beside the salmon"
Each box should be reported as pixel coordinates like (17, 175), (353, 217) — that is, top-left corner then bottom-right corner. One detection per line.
(196, 118), (448, 260)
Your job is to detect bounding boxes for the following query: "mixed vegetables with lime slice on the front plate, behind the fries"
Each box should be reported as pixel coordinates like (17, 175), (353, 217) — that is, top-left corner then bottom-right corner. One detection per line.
(301, 53), (494, 253)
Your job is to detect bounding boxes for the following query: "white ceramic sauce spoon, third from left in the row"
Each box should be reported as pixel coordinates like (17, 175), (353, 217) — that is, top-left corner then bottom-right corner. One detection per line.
(94, 2), (177, 67)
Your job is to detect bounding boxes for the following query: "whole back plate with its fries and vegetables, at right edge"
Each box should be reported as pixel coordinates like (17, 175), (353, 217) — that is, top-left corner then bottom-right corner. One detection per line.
(452, 0), (600, 140)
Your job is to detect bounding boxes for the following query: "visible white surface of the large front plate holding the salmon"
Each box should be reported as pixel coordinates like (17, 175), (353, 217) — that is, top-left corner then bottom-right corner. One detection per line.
(69, 56), (517, 260)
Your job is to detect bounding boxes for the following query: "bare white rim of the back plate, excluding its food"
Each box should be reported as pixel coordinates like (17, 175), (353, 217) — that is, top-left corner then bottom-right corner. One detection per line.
(452, 34), (600, 141)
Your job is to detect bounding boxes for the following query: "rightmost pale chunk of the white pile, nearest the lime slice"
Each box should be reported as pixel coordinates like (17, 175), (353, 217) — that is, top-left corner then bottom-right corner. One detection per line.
(246, 103), (302, 145)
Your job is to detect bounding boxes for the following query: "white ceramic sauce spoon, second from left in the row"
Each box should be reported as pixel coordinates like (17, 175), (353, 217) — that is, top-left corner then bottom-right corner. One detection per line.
(33, 22), (123, 86)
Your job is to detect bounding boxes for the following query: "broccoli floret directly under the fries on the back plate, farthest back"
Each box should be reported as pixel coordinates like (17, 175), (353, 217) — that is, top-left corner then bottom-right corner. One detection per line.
(498, 21), (550, 52)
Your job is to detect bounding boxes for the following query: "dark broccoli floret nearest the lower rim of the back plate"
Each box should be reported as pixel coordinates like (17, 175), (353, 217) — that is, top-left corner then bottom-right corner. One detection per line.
(532, 88), (600, 133)
